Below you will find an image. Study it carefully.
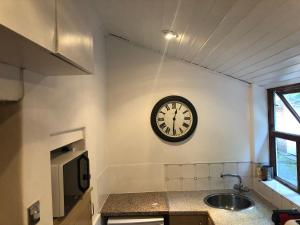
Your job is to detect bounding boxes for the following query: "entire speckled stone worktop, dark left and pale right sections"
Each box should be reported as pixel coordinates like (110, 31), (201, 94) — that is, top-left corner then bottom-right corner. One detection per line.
(101, 190), (274, 225)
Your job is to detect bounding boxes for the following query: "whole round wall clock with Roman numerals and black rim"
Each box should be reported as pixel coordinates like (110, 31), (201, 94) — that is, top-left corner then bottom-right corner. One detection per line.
(151, 95), (198, 142)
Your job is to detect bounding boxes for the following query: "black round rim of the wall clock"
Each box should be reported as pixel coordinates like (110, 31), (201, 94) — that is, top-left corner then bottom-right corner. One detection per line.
(151, 95), (198, 142)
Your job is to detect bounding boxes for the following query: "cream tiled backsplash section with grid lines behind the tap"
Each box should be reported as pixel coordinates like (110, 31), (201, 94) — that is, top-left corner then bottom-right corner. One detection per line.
(165, 162), (256, 191)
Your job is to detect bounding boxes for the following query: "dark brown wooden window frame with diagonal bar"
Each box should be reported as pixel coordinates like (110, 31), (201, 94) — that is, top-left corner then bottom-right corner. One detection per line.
(267, 83), (300, 193)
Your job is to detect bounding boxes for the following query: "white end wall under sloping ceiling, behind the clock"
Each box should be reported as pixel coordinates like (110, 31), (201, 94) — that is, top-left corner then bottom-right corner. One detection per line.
(107, 37), (251, 192)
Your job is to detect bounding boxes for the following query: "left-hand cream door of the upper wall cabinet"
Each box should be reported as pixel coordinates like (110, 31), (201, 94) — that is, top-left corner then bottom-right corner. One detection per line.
(0, 0), (55, 52)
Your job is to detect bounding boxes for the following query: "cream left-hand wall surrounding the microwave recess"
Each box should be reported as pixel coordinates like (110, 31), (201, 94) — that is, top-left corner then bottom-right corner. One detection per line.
(0, 14), (107, 225)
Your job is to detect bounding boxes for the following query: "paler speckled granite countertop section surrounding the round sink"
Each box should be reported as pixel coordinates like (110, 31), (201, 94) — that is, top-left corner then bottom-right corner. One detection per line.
(167, 190), (274, 225)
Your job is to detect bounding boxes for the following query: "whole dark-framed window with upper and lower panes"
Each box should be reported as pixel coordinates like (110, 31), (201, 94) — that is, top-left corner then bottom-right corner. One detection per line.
(268, 84), (300, 192)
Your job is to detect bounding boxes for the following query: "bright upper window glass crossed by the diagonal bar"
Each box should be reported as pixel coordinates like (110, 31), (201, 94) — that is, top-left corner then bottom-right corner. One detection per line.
(274, 94), (300, 134)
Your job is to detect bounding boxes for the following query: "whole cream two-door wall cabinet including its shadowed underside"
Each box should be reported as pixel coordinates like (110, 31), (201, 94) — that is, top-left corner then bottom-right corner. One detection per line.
(0, 0), (93, 75)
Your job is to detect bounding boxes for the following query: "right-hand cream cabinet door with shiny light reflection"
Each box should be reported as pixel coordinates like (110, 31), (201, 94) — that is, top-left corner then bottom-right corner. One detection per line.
(56, 0), (93, 72)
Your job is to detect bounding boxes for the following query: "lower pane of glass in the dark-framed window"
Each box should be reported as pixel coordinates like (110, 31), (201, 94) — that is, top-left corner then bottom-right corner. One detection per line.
(276, 138), (298, 187)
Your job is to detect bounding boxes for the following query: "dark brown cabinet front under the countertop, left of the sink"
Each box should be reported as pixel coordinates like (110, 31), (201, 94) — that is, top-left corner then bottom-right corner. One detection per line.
(169, 215), (209, 225)
